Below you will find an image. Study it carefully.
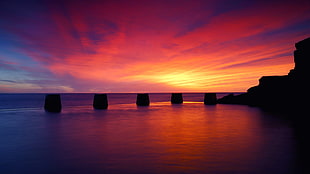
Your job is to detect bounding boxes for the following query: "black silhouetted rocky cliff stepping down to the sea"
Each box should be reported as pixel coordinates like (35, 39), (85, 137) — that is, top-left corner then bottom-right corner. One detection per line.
(217, 38), (310, 110)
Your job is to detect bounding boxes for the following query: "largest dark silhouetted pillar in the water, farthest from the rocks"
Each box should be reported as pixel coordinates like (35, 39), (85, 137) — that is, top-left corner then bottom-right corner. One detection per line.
(44, 94), (61, 112)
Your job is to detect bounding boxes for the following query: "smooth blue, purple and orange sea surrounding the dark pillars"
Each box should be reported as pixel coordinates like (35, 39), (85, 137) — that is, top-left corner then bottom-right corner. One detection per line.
(0, 94), (306, 174)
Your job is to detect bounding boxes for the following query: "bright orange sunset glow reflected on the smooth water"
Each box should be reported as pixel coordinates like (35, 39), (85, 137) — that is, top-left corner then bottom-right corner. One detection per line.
(145, 106), (262, 171)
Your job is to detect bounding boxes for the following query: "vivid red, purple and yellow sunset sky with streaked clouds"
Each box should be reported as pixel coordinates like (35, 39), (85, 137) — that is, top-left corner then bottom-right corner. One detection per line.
(0, 0), (310, 93)
